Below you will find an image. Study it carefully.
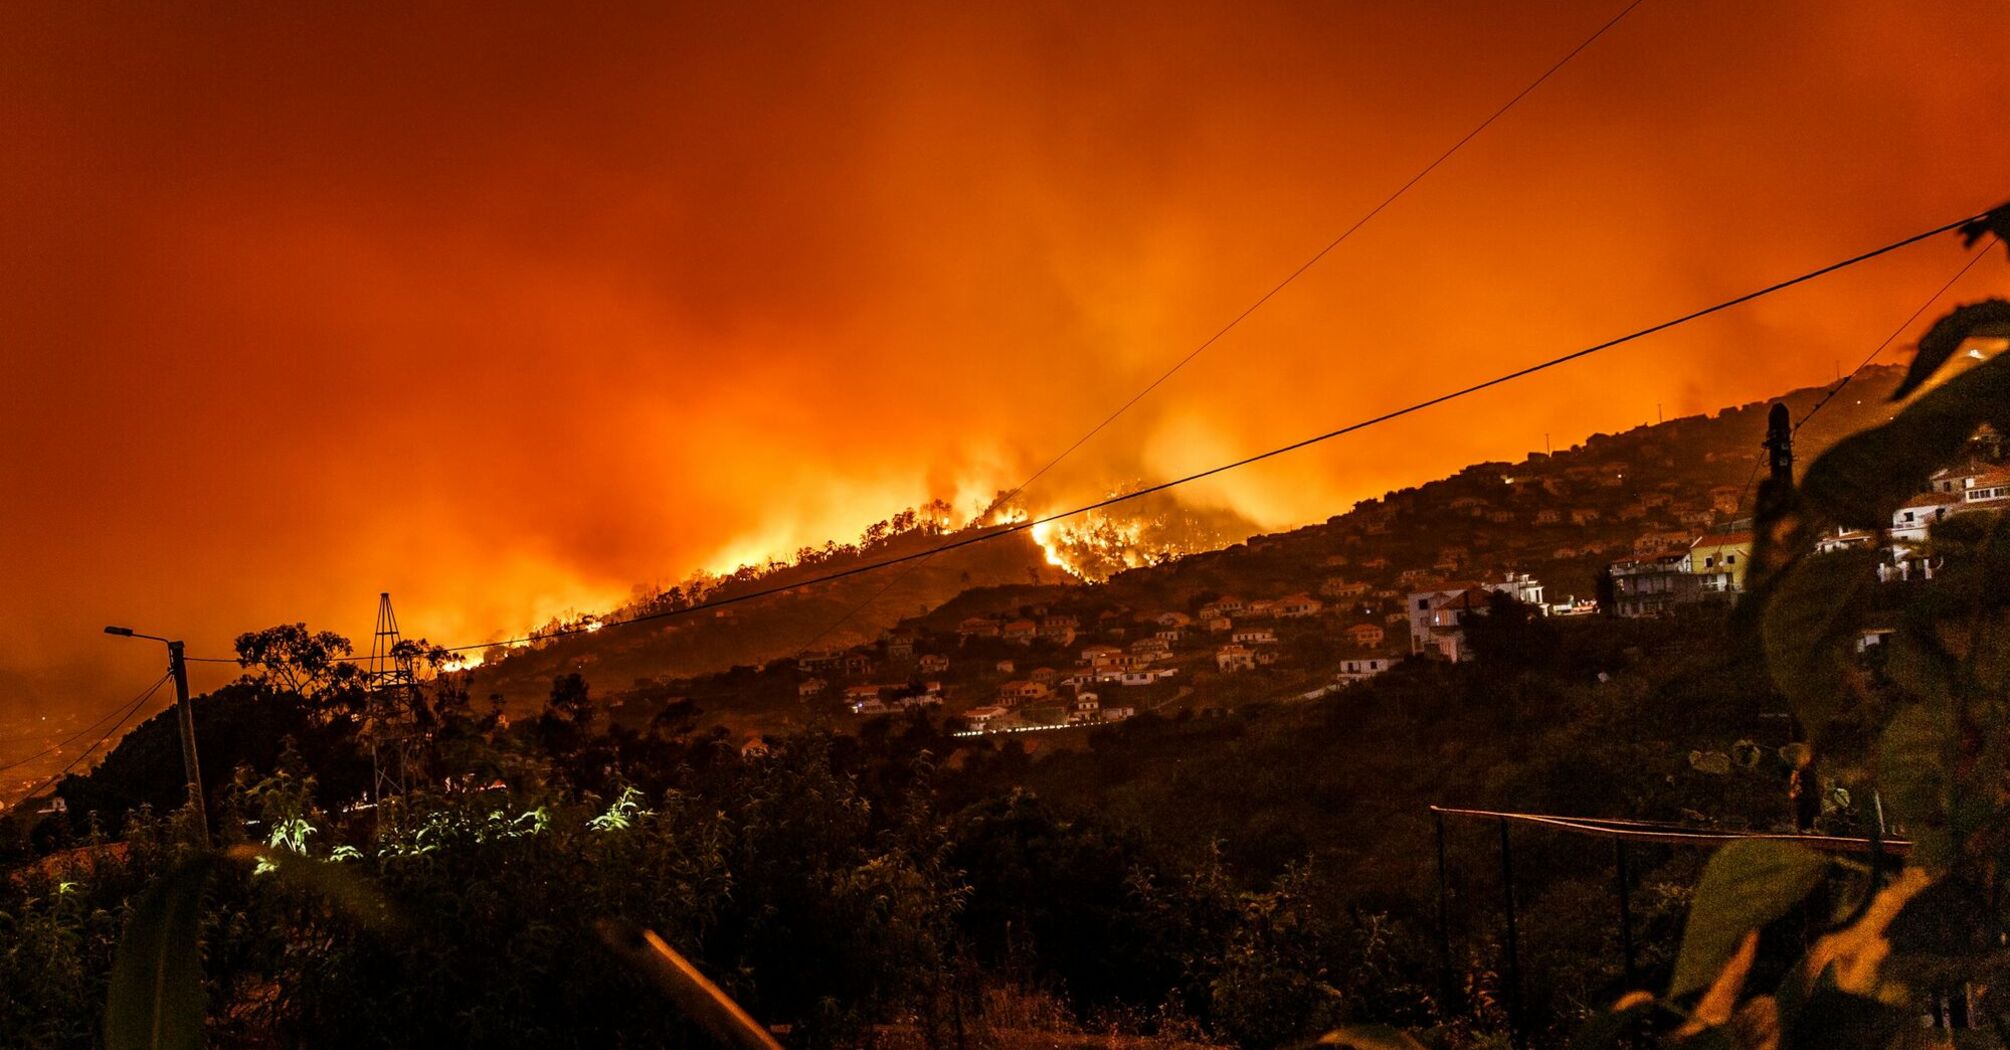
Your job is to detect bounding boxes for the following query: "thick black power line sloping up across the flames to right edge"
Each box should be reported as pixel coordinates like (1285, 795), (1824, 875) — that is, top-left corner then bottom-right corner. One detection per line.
(341, 213), (1986, 652)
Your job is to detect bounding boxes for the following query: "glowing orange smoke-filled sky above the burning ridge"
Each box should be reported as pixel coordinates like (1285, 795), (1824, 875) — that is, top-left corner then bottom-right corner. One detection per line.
(0, 0), (2010, 712)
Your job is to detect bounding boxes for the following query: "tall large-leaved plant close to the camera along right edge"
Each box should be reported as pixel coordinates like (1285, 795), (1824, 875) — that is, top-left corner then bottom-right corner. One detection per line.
(1580, 207), (2010, 1050)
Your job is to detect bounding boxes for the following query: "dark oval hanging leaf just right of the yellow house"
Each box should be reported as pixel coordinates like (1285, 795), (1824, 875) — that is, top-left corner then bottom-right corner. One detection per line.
(1761, 551), (1877, 728)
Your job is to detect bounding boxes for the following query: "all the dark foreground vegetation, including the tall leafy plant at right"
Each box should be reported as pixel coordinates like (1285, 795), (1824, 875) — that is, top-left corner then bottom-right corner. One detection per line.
(0, 208), (2010, 1048)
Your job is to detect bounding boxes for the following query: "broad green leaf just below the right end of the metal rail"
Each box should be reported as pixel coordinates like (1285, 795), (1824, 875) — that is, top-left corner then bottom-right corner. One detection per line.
(1668, 839), (1829, 998)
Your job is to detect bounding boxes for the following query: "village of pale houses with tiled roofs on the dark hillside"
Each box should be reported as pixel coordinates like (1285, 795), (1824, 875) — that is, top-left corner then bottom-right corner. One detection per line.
(679, 374), (2010, 734)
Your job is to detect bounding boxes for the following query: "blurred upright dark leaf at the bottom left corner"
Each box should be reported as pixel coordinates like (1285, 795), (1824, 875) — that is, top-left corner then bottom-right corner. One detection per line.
(105, 853), (217, 1050)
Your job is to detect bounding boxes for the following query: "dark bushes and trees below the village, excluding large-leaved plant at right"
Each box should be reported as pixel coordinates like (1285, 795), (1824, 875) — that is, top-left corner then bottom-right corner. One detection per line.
(0, 591), (1809, 1046)
